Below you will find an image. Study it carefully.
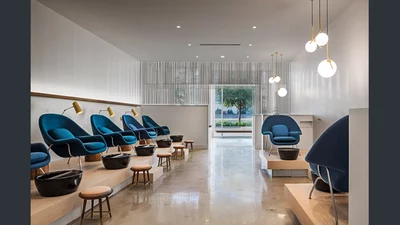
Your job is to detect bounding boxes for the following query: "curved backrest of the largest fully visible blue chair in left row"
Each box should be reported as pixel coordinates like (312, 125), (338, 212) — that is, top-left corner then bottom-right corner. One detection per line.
(39, 113), (89, 145)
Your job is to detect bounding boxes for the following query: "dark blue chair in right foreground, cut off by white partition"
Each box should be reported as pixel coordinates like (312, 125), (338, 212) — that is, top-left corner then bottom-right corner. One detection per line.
(305, 116), (349, 224)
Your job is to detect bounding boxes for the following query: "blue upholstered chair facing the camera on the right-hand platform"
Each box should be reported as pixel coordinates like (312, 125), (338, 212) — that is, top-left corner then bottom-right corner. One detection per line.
(261, 115), (302, 154)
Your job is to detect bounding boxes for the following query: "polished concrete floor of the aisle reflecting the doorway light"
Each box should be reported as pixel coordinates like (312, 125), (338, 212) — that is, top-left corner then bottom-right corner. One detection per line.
(71, 138), (310, 225)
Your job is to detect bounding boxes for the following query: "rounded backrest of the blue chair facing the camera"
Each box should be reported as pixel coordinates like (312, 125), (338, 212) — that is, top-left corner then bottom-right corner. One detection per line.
(261, 115), (301, 136)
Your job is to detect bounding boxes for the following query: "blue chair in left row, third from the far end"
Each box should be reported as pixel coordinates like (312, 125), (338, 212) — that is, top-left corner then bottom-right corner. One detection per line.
(90, 114), (137, 151)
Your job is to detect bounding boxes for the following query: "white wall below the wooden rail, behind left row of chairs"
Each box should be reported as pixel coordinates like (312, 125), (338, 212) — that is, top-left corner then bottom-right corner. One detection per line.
(31, 97), (141, 161)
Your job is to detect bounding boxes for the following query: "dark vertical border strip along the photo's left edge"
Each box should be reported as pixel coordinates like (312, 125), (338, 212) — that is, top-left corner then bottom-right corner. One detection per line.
(0, 0), (31, 225)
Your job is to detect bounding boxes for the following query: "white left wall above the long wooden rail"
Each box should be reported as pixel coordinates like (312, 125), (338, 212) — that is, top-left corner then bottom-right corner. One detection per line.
(31, 0), (141, 103)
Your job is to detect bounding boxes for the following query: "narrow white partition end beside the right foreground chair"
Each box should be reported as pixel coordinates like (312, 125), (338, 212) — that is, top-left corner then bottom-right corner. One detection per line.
(349, 109), (369, 225)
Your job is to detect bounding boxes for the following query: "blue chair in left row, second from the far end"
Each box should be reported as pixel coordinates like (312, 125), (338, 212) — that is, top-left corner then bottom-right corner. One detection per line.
(122, 115), (157, 140)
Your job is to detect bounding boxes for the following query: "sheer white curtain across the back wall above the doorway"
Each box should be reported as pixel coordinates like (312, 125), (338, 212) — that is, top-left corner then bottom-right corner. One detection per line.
(141, 62), (290, 113)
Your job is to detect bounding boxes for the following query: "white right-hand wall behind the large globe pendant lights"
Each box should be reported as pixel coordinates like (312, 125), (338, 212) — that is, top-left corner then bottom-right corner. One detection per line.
(291, 0), (368, 139)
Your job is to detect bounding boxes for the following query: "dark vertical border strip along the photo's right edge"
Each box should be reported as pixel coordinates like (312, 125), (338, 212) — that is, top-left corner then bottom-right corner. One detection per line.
(369, 0), (400, 225)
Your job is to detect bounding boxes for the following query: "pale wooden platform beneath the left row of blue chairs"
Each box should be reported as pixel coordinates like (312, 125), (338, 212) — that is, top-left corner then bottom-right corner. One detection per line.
(31, 143), (189, 225)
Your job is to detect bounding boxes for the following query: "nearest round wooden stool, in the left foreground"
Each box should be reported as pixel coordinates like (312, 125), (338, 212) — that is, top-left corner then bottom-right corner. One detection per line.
(79, 186), (114, 223)
